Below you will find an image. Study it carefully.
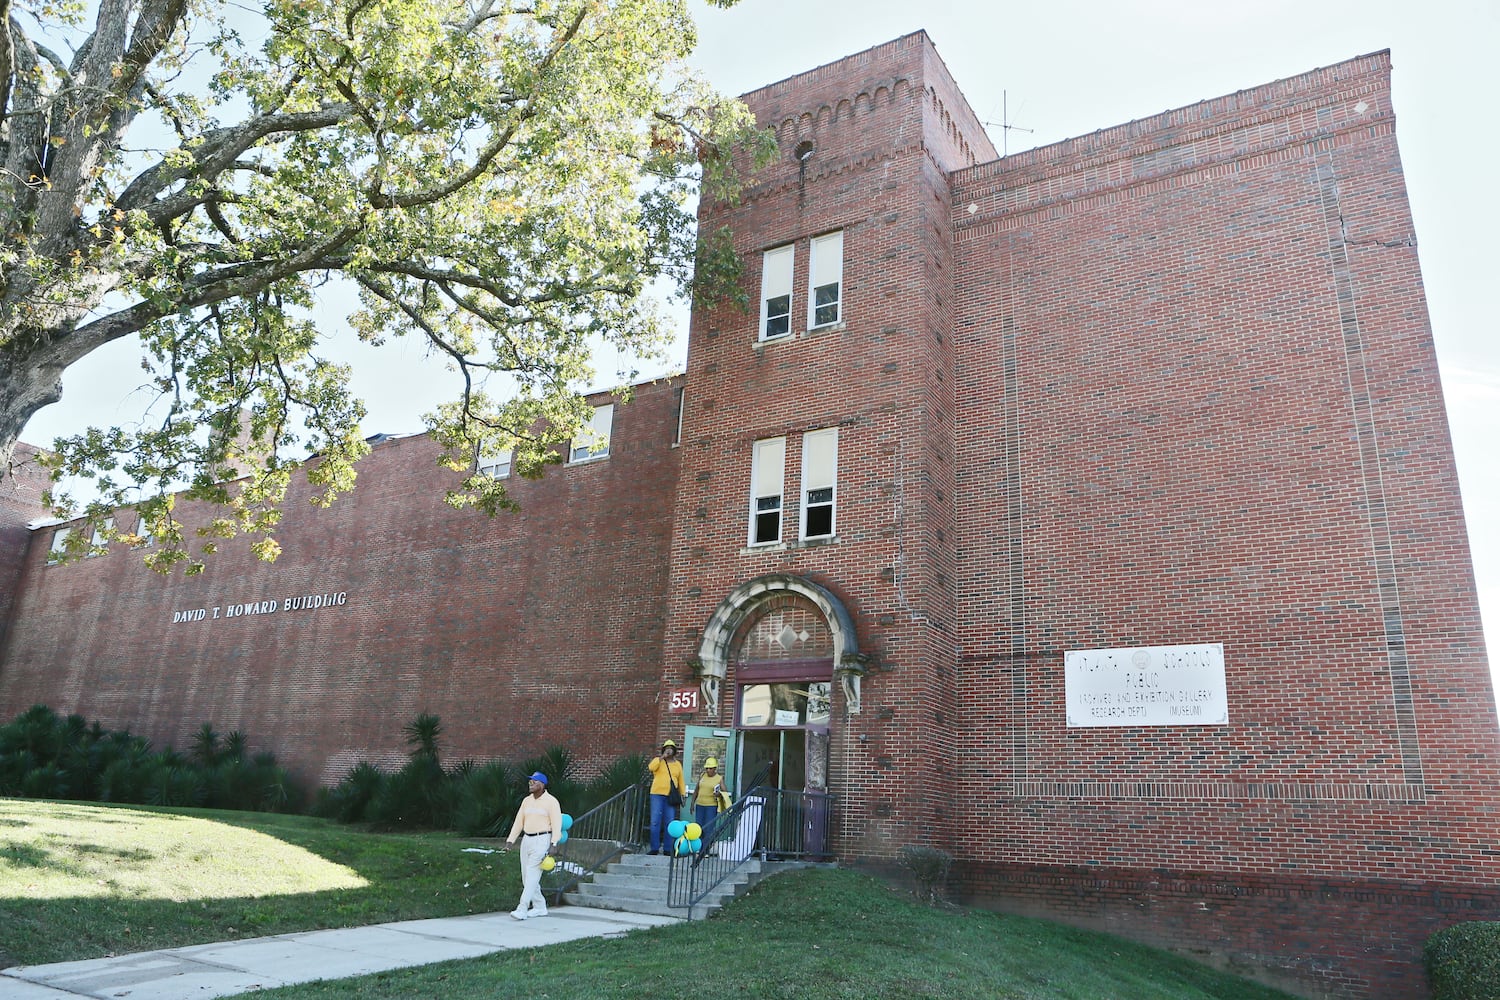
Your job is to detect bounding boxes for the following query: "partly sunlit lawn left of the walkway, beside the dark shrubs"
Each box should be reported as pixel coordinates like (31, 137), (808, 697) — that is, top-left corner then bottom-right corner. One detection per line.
(0, 799), (521, 969)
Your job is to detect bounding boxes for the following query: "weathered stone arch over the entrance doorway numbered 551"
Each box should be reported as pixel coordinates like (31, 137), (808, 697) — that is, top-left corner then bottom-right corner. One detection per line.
(698, 573), (867, 715)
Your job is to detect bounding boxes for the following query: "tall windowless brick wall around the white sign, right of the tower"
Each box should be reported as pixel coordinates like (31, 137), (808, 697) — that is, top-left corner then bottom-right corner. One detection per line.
(953, 54), (1500, 997)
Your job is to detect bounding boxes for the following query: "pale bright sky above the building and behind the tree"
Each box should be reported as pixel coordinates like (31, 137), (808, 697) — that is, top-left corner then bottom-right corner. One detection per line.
(23, 0), (1500, 687)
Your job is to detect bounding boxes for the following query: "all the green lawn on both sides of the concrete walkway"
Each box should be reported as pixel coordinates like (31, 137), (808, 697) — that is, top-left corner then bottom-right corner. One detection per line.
(0, 799), (1286, 1000)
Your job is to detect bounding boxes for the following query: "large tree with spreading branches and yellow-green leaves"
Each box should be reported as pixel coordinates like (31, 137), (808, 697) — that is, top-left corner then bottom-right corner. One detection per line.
(0, 0), (765, 571)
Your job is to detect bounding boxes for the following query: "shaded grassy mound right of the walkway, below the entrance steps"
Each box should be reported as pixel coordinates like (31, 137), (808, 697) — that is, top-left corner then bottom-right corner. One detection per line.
(258, 870), (1287, 1000)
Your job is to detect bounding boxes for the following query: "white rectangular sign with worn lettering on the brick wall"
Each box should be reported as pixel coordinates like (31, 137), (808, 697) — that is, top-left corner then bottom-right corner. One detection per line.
(1064, 642), (1229, 727)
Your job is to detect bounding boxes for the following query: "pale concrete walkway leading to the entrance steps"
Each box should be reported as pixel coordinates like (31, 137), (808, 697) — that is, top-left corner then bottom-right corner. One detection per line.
(0, 906), (680, 1000)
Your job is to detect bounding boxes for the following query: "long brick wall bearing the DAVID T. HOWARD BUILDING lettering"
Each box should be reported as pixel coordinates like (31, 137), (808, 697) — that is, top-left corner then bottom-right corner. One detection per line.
(0, 382), (678, 784)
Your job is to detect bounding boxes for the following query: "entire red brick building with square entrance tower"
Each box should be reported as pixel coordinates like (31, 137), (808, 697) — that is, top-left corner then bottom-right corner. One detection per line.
(0, 33), (1500, 997)
